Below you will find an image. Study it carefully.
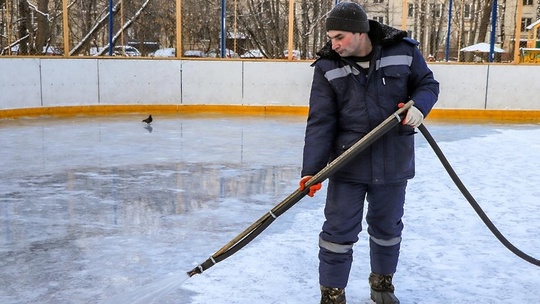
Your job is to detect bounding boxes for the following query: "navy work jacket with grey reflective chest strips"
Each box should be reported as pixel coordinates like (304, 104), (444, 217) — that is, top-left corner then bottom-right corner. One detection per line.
(302, 20), (439, 184)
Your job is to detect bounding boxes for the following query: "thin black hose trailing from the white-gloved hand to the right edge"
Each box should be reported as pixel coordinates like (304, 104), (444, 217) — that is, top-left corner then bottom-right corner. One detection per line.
(418, 124), (540, 266)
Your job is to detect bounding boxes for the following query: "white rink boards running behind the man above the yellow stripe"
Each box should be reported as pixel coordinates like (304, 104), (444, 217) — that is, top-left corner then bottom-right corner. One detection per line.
(0, 58), (540, 110)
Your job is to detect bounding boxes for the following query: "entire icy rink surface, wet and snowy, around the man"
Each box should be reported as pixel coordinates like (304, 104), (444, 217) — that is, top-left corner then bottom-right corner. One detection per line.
(0, 115), (540, 304)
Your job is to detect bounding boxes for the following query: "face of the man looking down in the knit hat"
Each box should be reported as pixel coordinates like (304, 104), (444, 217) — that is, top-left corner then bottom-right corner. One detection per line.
(326, 30), (371, 57)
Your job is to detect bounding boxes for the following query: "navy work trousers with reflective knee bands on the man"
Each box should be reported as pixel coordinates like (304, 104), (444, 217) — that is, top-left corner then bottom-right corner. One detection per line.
(319, 179), (407, 288)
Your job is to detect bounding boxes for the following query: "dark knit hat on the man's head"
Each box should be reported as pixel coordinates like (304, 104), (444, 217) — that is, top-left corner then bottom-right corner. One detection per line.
(326, 2), (369, 33)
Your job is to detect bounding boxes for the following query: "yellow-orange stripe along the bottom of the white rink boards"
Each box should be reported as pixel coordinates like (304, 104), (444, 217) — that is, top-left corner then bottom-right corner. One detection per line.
(0, 104), (540, 122)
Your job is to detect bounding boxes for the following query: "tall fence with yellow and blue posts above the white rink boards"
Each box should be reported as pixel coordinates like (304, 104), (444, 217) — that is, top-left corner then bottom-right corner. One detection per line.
(0, 0), (540, 63)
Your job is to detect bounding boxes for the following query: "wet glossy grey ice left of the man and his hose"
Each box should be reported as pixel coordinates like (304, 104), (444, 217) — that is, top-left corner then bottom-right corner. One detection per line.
(0, 115), (302, 304)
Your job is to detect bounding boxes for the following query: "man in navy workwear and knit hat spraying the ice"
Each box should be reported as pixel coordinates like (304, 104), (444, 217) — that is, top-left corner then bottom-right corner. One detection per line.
(300, 2), (439, 304)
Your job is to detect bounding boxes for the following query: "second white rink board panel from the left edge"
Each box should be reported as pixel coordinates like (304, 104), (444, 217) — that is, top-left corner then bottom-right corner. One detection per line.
(41, 59), (98, 107)
